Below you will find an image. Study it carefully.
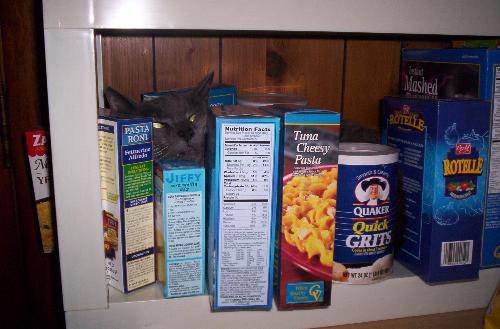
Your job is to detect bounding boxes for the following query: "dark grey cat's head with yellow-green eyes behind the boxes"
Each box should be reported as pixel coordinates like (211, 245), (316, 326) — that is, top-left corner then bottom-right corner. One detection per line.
(105, 73), (213, 164)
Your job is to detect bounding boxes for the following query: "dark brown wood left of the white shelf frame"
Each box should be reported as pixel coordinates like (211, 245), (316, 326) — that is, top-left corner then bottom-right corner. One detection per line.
(0, 0), (64, 328)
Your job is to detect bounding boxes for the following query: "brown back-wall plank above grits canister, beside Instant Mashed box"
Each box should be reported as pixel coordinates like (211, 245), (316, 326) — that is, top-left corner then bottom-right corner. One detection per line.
(342, 40), (401, 129)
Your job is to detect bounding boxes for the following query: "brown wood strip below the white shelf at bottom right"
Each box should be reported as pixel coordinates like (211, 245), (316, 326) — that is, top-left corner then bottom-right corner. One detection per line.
(321, 309), (485, 329)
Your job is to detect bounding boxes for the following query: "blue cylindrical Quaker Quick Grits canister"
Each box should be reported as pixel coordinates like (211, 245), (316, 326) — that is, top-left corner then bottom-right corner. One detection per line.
(333, 143), (399, 284)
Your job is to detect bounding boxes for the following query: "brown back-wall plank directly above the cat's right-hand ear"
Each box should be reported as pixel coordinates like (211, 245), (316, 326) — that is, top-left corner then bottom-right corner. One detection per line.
(154, 37), (219, 90)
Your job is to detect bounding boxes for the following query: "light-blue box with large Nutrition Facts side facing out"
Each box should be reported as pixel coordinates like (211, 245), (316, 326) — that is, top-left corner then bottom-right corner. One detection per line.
(207, 105), (280, 311)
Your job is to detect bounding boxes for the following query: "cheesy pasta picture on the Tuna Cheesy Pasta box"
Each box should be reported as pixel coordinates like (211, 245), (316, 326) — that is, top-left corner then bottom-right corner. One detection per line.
(281, 165), (338, 280)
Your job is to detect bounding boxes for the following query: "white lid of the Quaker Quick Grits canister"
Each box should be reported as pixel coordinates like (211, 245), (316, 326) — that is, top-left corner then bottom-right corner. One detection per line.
(339, 143), (399, 165)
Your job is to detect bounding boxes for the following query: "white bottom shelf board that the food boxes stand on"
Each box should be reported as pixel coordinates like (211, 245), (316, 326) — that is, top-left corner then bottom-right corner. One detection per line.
(66, 263), (500, 329)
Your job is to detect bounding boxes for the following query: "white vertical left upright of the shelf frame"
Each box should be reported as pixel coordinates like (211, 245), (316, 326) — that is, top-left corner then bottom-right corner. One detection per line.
(45, 30), (107, 311)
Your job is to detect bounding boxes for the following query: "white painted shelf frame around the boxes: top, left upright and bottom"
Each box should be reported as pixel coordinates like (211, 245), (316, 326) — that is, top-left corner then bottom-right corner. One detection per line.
(43, 0), (500, 328)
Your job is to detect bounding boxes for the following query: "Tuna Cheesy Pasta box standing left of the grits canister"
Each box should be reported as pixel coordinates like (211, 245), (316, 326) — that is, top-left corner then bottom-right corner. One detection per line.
(265, 106), (340, 309)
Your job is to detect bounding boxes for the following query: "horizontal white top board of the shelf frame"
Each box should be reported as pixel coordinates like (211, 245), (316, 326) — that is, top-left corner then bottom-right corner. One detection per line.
(43, 0), (500, 36)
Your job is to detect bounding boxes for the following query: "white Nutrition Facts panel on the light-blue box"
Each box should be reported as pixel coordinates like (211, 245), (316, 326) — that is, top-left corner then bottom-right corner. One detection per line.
(217, 123), (275, 306)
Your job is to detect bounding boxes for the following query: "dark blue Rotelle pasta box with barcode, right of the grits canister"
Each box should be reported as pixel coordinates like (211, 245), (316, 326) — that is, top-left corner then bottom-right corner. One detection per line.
(382, 97), (489, 283)
